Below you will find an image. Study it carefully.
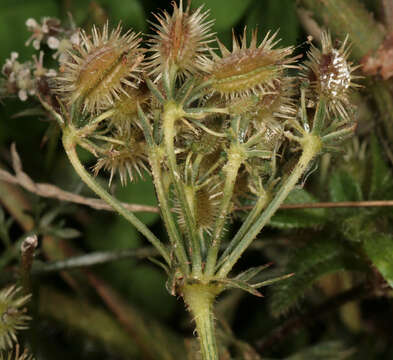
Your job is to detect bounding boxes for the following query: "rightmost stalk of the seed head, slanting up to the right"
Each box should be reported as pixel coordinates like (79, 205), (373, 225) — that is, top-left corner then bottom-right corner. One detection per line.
(217, 133), (321, 278)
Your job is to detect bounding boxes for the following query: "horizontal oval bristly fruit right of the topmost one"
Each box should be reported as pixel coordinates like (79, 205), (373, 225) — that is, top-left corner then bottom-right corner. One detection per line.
(205, 29), (294, 99)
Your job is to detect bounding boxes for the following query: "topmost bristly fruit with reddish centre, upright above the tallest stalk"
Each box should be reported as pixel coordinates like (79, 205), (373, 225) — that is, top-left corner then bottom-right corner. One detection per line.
(146, 1), (213, 81)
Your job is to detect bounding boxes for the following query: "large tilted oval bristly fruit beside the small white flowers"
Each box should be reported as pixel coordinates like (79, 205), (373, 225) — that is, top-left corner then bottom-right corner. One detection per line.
(57, 23), (143, 113)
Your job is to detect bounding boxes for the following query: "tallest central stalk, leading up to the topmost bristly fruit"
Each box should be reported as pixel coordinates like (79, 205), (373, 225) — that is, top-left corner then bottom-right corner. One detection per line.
(162, 101), (202, 277)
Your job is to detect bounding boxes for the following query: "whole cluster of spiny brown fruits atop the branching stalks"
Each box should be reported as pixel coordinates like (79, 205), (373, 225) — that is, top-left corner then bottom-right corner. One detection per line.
(3, 1), (357, 233)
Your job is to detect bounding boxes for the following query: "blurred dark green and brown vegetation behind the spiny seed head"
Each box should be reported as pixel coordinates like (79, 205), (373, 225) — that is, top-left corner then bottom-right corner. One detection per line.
(0, 0), (393, 360)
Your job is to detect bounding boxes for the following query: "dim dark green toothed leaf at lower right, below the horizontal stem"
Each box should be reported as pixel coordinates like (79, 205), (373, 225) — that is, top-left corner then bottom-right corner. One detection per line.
(271, 238), (359, 315)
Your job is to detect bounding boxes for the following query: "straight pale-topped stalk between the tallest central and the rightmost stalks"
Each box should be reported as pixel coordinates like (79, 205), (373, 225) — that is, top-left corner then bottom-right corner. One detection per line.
(205, 145), (244, 276)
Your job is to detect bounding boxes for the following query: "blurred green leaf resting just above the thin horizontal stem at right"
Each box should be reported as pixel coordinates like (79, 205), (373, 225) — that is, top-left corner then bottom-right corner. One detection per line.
(329, 171), (363, 202)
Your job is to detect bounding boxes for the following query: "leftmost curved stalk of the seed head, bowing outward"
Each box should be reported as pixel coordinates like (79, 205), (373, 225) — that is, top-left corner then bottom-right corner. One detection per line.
(63, 126), (171, 264)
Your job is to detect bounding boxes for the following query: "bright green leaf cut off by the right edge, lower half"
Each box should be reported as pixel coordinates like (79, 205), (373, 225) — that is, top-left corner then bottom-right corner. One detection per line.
(363, 234), (393, 287)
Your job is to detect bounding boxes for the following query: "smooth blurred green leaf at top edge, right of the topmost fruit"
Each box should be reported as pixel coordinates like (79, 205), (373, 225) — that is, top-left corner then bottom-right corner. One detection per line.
(192, 0), (253, 31)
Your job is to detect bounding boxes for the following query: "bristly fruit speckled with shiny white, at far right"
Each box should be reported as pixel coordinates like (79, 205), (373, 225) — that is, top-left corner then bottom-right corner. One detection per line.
(300, 31), (360, 120)
